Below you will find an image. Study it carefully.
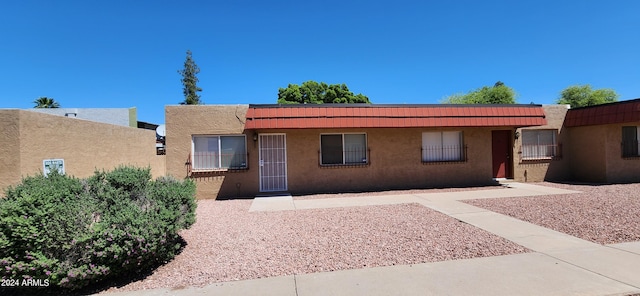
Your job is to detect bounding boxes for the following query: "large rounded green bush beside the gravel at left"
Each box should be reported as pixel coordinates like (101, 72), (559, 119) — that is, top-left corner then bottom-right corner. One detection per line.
(0, 167), (196, 289)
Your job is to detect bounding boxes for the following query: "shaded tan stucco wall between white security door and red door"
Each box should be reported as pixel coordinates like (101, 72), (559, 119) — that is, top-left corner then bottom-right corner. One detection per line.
(278, 128), (492, 194)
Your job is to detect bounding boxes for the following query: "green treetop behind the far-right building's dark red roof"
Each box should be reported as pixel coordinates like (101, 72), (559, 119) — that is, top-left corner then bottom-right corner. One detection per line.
(557, 84), (619, 108)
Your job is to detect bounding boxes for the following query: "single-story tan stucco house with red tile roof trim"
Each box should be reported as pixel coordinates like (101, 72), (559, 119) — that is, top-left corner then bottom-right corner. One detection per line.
(165, 99), (640, 198)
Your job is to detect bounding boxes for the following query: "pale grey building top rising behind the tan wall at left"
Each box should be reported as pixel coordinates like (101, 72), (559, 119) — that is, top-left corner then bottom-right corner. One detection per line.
(25, 107), (138, 127)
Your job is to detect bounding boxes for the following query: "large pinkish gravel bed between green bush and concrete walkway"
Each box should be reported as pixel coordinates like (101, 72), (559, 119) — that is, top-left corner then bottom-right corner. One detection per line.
(106, 200), (528, 292)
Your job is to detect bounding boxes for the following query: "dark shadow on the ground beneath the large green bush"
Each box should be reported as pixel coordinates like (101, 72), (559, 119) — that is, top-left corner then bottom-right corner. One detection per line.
(0, 236), (187, 296)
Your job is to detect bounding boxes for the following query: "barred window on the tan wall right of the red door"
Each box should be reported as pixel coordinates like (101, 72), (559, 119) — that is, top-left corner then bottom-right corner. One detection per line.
(522, 130), (558, 160)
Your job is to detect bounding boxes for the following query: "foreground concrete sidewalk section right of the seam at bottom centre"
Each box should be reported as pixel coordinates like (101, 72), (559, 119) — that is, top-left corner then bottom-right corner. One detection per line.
(296, 253), (640, 296)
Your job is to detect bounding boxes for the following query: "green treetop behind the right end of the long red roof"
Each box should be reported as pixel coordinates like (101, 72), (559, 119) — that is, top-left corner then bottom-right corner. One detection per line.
(442, 81), (516, 104)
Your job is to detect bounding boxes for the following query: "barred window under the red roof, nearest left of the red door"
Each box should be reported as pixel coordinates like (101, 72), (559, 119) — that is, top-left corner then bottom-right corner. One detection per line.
(422, 131), (466, 162)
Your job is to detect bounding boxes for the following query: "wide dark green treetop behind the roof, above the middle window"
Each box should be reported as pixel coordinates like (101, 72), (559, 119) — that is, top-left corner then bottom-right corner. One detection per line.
(278, 81), (371, 104)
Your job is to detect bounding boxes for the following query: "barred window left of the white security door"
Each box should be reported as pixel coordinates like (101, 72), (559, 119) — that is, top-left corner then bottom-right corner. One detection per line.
(192, 135), (247, 171)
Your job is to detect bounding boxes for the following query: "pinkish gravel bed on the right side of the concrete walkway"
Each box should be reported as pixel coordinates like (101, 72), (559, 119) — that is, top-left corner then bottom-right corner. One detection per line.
(465, 182), (640, 244)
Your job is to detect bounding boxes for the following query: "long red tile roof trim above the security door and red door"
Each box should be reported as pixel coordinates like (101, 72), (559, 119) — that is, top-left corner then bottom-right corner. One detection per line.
(245, 104), (547, 129)
